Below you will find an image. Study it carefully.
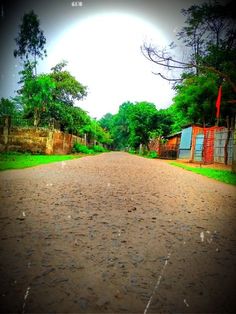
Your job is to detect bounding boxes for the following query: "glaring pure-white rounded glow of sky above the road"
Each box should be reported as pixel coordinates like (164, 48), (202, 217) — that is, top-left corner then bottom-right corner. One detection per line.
(44, 13), (174, 119)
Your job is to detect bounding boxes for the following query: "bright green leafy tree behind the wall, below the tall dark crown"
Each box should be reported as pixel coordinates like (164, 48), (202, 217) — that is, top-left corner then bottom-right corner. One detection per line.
(18, 62), (95, 135)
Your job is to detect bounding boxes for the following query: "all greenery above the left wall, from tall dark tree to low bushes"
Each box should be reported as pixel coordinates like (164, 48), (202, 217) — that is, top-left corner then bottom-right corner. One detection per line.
(0, 11), (112, 145)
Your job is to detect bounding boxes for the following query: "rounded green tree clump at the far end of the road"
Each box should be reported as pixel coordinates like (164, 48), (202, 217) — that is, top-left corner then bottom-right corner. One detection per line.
(100, 102), (173, 150)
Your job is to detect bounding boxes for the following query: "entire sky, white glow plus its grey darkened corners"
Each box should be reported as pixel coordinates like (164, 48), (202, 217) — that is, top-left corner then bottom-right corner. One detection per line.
(0, 0), (206, 119)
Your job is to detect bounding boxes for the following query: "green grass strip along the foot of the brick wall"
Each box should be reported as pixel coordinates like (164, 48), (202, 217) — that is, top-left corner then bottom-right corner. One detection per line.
(0, 153), (84, 171)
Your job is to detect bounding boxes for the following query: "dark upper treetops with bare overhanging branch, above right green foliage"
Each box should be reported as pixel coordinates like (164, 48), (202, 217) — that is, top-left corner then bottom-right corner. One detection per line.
(141, 2), (236, 93)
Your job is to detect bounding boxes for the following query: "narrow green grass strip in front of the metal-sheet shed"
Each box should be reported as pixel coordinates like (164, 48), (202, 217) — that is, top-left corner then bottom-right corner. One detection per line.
(169, 162), (236, 185)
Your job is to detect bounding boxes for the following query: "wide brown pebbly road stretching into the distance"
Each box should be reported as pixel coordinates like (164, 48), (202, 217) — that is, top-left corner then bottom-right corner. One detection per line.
(0, 153), (236, 313)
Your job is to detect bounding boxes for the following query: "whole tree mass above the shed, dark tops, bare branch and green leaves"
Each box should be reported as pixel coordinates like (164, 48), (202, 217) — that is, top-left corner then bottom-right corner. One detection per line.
(142, 1), (236, 130)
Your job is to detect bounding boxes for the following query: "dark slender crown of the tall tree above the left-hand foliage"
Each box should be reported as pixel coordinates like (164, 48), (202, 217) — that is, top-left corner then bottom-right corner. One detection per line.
(14, 10), (46, 75)
